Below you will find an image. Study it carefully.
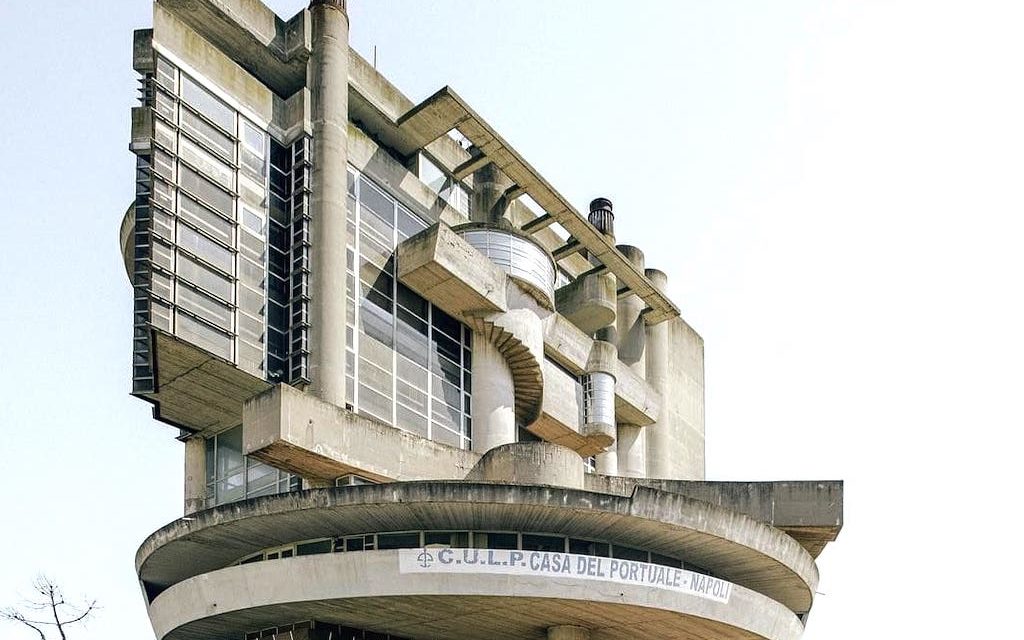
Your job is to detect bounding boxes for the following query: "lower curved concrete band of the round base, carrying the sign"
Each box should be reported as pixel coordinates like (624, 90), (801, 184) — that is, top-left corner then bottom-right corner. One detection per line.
(150, 551), (803, 640)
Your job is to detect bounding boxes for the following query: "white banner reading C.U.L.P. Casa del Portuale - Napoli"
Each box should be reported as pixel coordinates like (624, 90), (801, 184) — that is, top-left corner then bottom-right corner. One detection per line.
(398, 549), (732, 603)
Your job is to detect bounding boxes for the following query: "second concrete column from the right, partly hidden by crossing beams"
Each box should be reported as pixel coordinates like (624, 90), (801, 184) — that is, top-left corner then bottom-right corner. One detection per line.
(615, 245), (647, 478)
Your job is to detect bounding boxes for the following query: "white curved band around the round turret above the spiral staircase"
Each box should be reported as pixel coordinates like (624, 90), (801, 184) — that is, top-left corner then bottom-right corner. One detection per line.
(452, 222), (555, 310)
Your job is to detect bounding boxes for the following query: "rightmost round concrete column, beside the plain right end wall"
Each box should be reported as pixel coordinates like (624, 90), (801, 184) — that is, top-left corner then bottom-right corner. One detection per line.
(644, 269), (674, 478)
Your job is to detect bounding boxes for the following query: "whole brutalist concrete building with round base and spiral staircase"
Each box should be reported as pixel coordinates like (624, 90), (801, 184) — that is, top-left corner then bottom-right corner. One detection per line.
(121, 0), (843, 640)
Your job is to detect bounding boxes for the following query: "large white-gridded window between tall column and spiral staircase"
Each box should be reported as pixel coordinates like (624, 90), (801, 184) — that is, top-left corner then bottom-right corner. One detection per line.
(346, 173), (472, 449)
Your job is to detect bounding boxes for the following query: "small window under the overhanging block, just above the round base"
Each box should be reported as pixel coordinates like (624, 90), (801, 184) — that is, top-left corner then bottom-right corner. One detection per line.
(206, 425), (301, 508)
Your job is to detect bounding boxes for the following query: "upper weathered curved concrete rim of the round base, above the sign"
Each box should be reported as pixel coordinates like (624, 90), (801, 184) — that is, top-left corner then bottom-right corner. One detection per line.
(135, 481), (818, 612)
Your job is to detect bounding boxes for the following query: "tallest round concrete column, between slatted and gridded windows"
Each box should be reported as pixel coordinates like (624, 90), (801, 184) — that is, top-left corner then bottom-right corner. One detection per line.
(306, 0), (348, 407)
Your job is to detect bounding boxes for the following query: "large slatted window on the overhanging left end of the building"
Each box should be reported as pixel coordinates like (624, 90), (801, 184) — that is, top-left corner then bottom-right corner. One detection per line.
(136, 57), (269, 378)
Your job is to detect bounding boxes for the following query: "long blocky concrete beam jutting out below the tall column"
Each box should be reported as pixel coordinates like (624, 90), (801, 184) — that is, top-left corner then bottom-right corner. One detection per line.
(242, 384), (479, 481)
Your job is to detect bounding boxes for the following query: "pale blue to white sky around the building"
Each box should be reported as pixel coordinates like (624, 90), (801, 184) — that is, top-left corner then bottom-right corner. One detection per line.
(0, 0), (1024, 640)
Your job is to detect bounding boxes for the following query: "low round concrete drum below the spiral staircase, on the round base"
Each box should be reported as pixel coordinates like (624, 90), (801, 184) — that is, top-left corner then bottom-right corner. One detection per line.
(466, 442), (584, 488)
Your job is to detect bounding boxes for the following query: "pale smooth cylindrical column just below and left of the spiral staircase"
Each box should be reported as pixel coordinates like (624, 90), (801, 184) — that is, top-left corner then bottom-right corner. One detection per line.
(471, 334), (518, 454)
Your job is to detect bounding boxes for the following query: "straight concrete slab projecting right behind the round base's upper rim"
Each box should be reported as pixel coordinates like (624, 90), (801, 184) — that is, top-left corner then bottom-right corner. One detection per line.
(586, 474), (843, 558)
